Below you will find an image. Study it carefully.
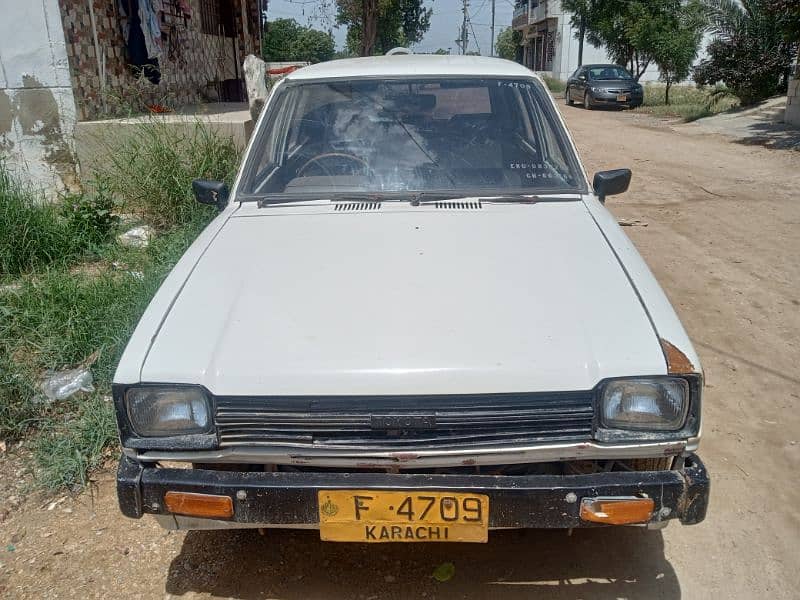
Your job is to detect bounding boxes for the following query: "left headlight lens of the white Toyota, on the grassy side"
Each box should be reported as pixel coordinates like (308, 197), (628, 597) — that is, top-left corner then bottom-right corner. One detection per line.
(125, 386), (212, 437)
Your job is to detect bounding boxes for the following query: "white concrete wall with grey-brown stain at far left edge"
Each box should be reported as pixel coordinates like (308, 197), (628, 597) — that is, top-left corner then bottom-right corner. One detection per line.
(0, 0), (77, 196)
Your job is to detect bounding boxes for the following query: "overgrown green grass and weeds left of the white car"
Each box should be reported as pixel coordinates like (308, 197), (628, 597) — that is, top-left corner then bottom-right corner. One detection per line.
(0, 119), (239, 489)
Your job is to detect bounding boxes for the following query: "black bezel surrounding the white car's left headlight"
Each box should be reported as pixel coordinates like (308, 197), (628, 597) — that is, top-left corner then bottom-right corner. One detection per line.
(112, 383), (219, 450)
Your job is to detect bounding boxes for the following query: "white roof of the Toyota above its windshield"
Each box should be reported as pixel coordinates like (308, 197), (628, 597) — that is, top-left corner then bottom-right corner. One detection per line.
(286, 54), (538, 81)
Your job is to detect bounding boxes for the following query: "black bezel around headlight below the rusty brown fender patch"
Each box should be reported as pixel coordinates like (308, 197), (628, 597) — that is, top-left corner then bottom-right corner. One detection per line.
(594, 373), (703, 444)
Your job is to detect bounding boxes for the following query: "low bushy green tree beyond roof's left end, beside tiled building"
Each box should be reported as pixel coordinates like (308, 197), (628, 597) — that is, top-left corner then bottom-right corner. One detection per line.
(262, 19), (335, 63)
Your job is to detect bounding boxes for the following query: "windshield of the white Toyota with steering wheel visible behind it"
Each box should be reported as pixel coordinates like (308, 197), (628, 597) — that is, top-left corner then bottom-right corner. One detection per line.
(239, 79), (585, 201)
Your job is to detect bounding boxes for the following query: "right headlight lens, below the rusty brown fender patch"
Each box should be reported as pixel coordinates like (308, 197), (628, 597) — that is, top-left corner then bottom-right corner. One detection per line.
(600, 377), (689, 431)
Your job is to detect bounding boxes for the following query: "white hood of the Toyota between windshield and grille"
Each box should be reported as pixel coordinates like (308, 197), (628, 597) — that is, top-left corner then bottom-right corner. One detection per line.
(141, 201), (666, 395)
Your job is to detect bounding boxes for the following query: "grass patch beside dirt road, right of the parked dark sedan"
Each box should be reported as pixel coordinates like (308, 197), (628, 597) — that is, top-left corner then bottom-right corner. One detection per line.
(636, 83), (739, 122)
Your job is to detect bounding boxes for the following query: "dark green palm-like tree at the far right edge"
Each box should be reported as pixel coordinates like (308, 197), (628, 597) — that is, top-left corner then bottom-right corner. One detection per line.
(694, 0), (798, 105)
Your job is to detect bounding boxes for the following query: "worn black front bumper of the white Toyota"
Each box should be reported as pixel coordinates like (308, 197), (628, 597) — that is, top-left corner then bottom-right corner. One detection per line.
(117, 454), (709, 529)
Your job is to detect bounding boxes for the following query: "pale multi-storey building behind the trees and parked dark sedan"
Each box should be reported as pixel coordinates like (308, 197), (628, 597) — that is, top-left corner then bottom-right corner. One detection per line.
(511, 0), (658, 81)
